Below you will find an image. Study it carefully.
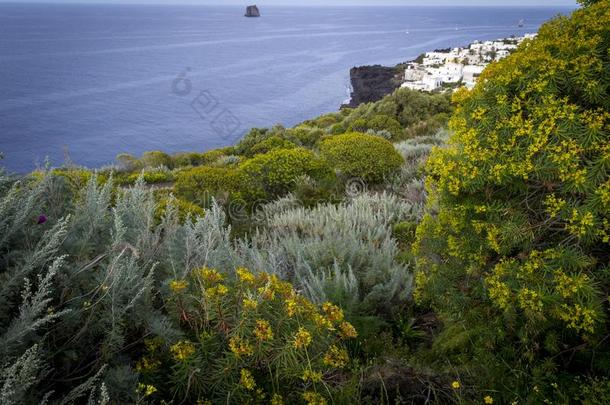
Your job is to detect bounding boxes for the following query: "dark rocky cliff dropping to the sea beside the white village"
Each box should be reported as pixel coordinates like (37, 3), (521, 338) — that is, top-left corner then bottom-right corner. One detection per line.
(346, 65), (402, 107)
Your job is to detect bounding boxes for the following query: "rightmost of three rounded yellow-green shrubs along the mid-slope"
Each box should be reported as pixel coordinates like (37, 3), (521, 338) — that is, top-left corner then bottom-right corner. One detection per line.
(320, 132), (403, 182)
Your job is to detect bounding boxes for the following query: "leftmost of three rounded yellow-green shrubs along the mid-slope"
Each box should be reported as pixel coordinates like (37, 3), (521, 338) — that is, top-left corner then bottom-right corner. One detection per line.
(174, 166), (256, 207)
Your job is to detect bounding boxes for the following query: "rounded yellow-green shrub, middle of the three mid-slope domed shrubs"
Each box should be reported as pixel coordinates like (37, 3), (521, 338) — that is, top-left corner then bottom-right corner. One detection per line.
(240, 148), (331, 196)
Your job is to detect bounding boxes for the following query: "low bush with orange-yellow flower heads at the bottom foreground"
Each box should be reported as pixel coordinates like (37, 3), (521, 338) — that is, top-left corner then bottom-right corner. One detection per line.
(137, 268), (358, 403)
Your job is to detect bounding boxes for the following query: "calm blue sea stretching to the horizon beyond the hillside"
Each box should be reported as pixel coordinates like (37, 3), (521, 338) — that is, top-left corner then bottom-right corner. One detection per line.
(0, 4), (570, 172)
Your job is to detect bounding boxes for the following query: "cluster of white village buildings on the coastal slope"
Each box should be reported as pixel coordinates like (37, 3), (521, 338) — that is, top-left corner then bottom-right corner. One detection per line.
(401, 34), (536, 92)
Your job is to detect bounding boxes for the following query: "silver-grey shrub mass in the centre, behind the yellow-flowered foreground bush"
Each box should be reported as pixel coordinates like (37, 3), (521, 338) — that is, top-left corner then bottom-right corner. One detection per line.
(237, 192), (420, 310)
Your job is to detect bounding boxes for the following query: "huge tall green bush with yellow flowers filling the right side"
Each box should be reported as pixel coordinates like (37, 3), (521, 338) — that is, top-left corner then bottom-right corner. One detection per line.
(415, 0), (610, 402)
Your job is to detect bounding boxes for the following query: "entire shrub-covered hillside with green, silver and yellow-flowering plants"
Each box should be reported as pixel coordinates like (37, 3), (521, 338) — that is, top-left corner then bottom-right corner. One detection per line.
(0, 0), (610, 405)
